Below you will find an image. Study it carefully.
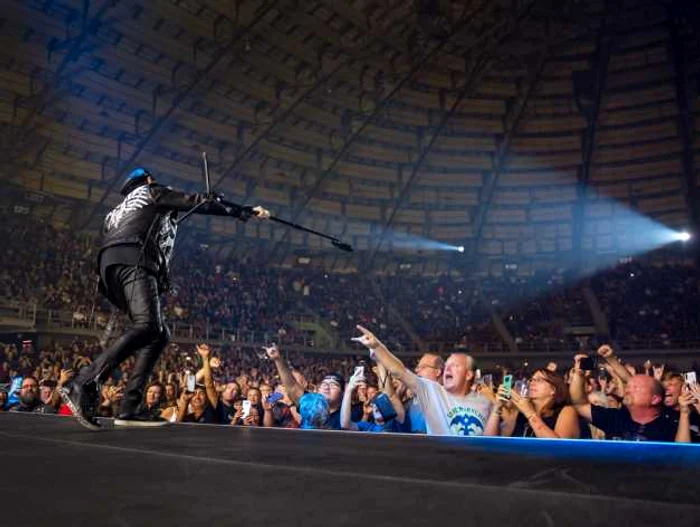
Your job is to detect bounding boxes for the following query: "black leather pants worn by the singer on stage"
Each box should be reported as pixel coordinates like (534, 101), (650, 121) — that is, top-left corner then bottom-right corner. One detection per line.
(75, 265), (170, 414)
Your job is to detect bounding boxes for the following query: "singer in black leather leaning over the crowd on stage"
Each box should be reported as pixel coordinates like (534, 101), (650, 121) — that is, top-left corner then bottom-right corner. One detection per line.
(61, 168), (270, 429)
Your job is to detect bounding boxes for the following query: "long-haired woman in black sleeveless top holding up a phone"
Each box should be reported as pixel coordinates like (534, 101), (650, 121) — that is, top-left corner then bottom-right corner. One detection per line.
(484, 369), (580, 439)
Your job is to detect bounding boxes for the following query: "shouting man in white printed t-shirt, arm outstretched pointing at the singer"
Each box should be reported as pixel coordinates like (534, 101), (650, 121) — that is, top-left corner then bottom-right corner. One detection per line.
(353, 326), (491, 436)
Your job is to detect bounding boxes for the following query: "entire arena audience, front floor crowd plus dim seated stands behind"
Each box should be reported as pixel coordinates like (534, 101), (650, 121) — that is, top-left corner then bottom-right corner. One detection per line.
(0, 218), (700, 442)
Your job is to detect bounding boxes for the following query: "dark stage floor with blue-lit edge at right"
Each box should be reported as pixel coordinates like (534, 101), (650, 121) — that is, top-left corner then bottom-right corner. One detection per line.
(0, 413), (700, 527)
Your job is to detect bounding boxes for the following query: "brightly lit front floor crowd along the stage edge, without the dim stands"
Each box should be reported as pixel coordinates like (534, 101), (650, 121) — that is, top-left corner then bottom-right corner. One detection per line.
(0, 336), (700, 442)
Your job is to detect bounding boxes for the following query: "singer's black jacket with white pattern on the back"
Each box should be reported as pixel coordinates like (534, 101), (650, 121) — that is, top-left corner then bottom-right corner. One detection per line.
(97, 183), (253, 293)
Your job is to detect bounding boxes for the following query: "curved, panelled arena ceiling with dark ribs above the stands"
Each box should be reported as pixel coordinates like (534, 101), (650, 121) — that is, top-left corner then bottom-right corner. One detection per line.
(0, 0), (700, 268)
